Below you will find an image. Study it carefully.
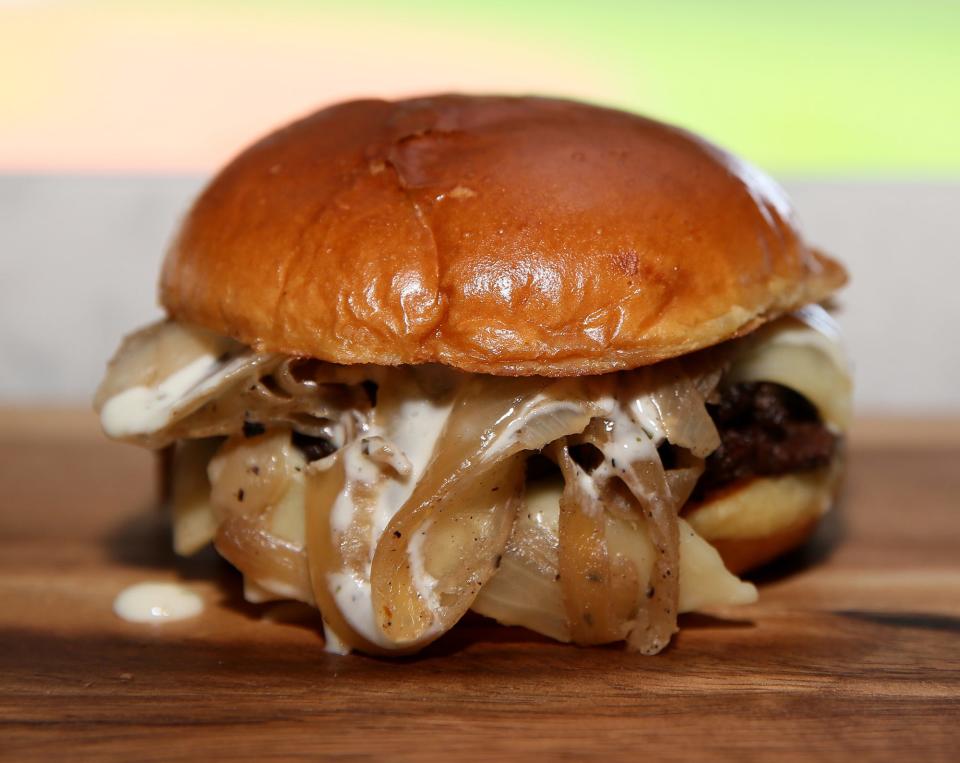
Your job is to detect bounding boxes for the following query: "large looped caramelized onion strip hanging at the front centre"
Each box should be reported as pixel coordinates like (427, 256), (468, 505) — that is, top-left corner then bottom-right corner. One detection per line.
(371, 378), (595, 644)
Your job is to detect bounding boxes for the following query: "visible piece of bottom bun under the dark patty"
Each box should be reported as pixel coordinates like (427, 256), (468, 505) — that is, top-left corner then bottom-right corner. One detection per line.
(683, 459), (841, 574)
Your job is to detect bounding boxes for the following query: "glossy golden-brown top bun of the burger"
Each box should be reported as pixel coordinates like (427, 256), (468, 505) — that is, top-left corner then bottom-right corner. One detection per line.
(161, 95), (846, 376)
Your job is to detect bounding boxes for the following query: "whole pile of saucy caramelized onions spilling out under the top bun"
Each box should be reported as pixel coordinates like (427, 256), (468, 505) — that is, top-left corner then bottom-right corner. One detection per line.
(107, 314), (804, 654)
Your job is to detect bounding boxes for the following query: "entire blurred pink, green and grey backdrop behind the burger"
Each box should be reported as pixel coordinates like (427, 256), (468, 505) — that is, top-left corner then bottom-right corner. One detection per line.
(0, 0), (960, 415)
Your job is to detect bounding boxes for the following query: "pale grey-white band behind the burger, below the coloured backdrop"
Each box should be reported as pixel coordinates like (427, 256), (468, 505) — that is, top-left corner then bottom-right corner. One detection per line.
(0, 176), (960, 414)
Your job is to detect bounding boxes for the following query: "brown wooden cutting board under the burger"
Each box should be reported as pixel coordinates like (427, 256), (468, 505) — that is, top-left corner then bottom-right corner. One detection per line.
(0, 411), (960, 761)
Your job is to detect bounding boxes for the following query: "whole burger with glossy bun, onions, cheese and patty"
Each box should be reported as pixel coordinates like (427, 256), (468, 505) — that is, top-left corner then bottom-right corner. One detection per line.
(95, 95), (851, 654)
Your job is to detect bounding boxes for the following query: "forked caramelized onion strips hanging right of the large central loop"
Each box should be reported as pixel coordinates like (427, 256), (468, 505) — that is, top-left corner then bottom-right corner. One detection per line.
(554, 363), (718, 654)
